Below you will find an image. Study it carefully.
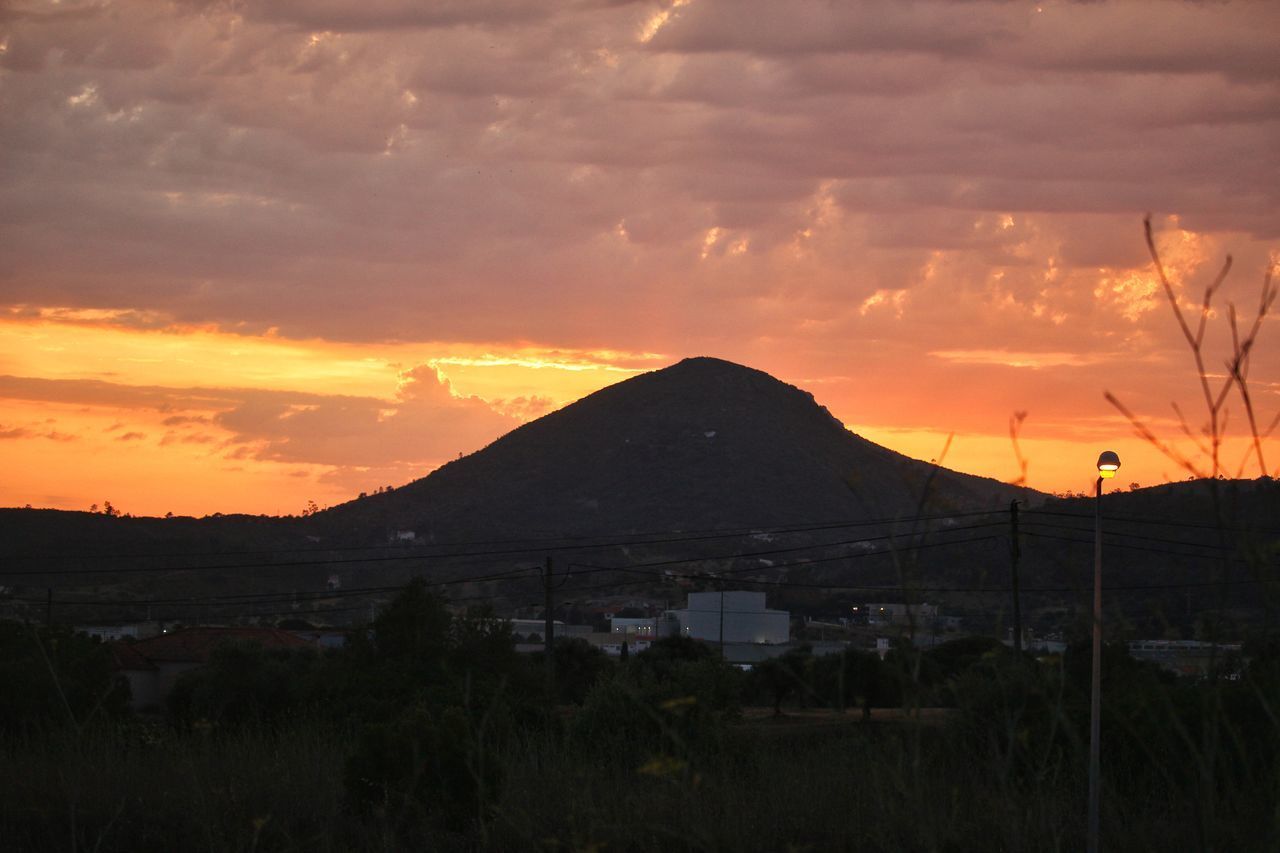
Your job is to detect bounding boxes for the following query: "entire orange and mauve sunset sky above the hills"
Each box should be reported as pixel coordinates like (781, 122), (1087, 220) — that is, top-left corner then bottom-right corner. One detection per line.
(0, 0), (1280, 515)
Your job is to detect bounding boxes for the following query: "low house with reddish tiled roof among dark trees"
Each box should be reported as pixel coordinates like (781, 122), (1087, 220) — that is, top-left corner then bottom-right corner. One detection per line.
(110, 625), (315, 711)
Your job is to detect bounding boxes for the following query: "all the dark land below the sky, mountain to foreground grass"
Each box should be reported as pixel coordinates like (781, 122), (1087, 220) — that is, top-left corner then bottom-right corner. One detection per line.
(0, 359), (1280, 850)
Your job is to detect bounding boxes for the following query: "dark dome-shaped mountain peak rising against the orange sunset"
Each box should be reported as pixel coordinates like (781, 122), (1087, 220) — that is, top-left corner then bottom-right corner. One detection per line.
(322, 357), (1042, 542)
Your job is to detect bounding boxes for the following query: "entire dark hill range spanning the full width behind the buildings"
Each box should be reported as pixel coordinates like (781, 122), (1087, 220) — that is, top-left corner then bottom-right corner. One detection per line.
(0, 357), (1280, 634)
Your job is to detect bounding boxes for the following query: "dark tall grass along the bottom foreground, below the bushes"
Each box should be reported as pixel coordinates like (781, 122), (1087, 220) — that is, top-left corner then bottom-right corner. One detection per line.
(0, 696), (1280, 853)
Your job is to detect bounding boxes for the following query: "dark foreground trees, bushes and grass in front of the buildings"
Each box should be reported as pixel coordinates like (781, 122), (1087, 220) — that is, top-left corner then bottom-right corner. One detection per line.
(0, 587), (1280, 853)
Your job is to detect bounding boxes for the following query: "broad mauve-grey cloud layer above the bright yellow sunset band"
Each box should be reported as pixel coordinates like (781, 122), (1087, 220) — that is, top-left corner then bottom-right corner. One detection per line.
(0, 0), (1280, 368)
